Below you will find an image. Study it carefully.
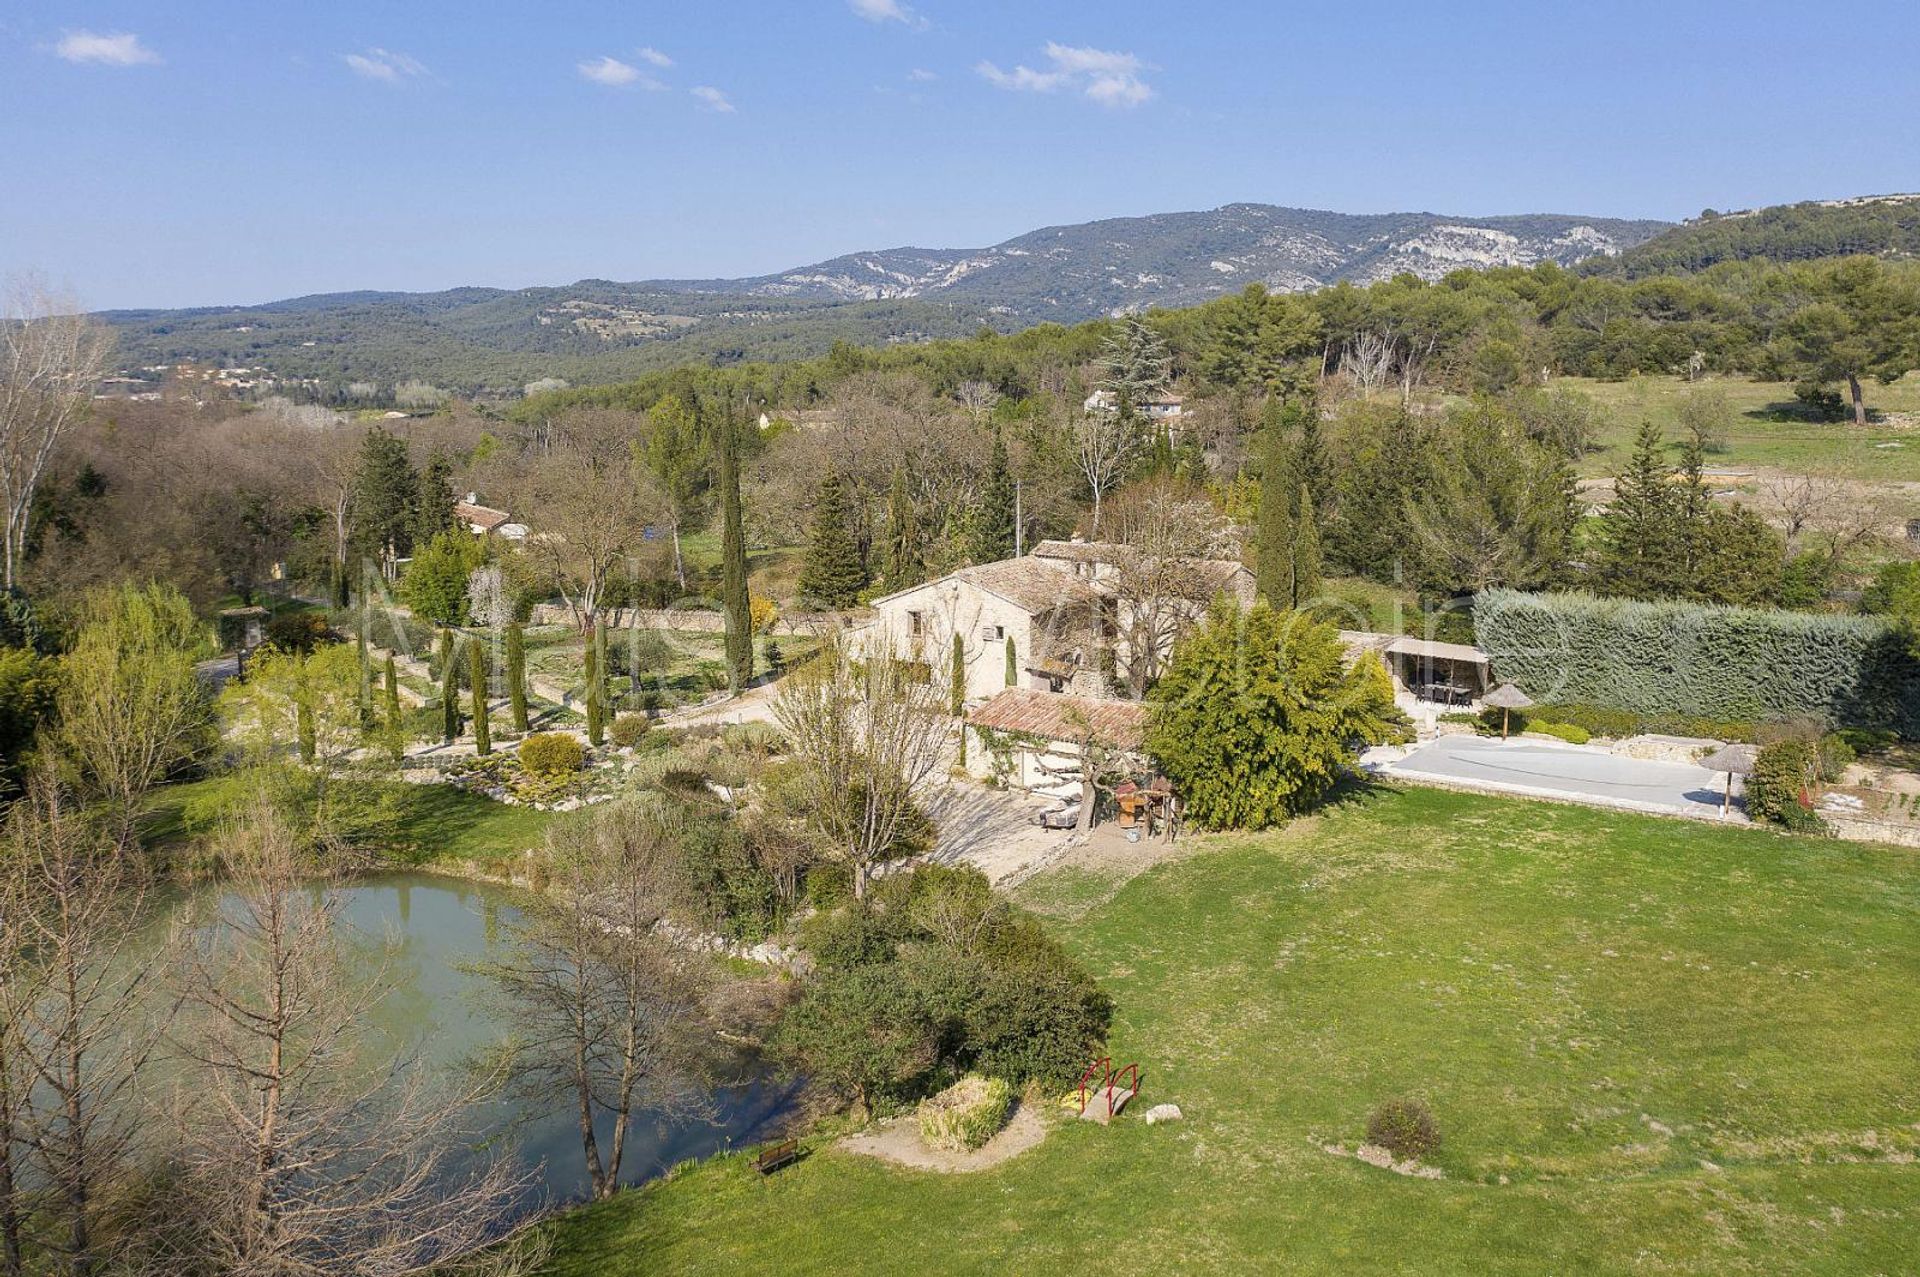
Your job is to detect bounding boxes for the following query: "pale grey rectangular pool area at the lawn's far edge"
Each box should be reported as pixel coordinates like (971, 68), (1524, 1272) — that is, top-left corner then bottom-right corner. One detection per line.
(1375, 735), (1745, 820)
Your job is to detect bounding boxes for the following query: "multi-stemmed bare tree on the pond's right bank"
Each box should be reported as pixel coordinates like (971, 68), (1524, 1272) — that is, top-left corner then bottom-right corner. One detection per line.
(484, 803), (707, 1198)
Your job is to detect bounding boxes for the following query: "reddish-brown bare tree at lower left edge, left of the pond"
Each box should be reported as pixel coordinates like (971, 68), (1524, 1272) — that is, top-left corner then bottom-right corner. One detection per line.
(0, 774), (157, 1277)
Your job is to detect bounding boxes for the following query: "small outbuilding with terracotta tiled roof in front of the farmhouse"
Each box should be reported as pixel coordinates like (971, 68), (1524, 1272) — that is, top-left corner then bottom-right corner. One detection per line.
(966, 687), (1146, 801)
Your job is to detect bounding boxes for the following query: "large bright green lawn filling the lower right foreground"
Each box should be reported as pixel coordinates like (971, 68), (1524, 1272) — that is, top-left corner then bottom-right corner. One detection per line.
(551, 791), (1920, 1277)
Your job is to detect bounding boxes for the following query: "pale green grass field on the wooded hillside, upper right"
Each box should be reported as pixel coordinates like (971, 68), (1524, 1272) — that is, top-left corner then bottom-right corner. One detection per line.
(1553, 374), (1920, 482)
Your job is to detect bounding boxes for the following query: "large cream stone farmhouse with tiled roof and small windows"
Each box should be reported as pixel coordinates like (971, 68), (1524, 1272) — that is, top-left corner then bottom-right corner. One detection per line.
(864, 542), (1254, 703)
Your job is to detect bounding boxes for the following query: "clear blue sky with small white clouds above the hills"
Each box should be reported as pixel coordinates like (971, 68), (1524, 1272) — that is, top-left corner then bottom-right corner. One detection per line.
(0, 0), (1920, 307)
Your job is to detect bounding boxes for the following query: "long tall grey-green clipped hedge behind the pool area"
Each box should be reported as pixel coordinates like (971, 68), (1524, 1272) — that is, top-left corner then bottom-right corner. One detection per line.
(1473, 590), (1920, 725)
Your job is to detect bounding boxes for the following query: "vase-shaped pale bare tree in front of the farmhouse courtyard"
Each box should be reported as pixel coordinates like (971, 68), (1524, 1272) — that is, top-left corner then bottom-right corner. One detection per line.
(774, 639), (948, 899)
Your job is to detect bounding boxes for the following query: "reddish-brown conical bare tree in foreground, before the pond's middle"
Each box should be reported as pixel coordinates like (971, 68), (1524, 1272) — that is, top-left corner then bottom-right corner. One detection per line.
(152, 803), (540, 1277)
